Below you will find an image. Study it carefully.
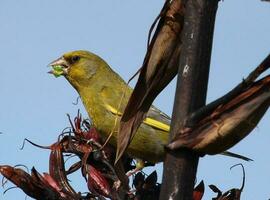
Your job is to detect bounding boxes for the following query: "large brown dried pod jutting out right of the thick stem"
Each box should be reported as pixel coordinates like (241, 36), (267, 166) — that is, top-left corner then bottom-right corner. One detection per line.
(168, 75), (270, 154)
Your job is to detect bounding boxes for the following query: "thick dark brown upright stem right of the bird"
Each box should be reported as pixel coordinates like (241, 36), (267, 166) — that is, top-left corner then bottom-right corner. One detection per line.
(160, 0), (218, 200)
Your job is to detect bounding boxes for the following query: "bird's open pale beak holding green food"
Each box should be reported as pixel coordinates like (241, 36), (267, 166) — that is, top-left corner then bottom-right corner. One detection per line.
(48, 57), (69, 77)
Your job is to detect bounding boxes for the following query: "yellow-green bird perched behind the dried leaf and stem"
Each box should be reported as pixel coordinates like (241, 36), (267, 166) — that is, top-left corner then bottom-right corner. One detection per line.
(50, 50), (249, 163)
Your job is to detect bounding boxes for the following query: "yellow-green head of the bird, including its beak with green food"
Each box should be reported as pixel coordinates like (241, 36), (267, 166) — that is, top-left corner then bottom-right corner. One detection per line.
(49, 50), (108, 88)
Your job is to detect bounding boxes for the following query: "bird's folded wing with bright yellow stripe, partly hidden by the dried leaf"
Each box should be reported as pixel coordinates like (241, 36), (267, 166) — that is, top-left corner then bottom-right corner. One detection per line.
(105, 104), (171, 132)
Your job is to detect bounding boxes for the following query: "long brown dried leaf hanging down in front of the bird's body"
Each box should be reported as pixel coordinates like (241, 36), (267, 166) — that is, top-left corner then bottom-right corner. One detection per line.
(116, 0), (186, 162)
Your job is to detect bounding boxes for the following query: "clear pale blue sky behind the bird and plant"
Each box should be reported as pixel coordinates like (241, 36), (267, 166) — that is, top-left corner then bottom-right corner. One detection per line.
(0, 0), (270, 200)
